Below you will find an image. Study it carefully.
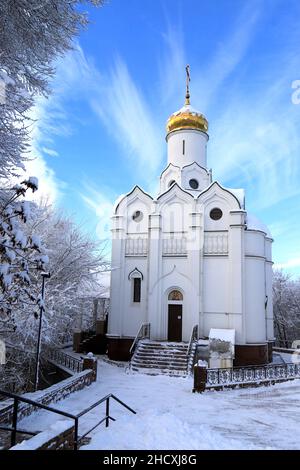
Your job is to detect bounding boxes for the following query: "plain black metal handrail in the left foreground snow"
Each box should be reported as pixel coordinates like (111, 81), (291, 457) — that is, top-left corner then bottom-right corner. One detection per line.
(0, 390), (136, 450)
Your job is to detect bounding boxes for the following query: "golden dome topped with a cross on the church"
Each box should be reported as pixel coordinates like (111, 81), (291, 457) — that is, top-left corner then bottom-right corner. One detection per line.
(167, 65), (208, 135)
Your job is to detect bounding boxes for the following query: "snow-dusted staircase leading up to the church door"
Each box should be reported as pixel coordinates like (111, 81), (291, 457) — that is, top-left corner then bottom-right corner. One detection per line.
(130, 339), (188, 376)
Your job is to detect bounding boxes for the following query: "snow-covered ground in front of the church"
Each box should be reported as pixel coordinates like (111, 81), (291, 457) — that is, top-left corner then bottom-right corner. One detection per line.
(22, 358), (300, 450)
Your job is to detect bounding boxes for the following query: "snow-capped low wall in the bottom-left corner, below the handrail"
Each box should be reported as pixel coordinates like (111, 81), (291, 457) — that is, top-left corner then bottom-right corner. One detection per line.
(10, 420), (74, 450)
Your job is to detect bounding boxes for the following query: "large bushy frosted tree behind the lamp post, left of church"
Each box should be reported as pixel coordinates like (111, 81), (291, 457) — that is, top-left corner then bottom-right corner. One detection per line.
(0, 204), (108, 391)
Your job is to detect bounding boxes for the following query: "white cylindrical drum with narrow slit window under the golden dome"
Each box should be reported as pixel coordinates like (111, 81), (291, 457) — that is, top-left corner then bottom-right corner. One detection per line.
(167, 129), (208, 168)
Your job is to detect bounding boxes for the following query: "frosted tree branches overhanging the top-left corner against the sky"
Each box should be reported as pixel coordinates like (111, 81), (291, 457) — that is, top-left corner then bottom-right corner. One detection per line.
(0, 0), (102, 179)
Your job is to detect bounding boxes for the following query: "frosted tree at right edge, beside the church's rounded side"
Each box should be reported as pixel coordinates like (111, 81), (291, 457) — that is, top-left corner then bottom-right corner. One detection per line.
(273, 271), (300, 347)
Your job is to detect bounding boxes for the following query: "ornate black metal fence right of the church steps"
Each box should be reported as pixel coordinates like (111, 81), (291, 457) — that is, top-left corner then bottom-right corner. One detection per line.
(206, 363), (300, 388)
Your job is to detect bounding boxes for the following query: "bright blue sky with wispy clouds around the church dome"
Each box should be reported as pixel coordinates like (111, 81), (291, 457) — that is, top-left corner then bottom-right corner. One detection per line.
(29, 0), (300, 275)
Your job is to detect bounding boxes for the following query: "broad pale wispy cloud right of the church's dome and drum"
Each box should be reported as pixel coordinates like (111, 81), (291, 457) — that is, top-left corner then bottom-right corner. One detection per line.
(209, 64), (300, 210)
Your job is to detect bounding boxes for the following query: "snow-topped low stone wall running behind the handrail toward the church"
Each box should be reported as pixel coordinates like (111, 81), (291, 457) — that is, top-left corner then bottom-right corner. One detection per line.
(0, 369), (96, 424)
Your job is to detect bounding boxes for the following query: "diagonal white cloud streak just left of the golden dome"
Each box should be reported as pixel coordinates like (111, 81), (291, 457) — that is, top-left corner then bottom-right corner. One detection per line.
(91, 58), (164, 180)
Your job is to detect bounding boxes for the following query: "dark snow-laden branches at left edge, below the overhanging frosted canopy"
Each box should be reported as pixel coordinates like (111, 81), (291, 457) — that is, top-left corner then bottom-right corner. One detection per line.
(0, 177), (48, 322)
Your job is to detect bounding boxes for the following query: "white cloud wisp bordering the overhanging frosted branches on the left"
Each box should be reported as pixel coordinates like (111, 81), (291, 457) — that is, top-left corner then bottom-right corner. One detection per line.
(26, 43), (99, 202)
